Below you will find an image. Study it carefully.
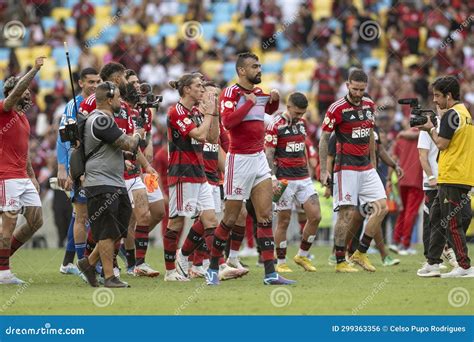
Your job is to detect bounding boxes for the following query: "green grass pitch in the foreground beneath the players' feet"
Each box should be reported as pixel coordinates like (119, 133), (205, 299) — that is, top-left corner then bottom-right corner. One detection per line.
(0, 245), (474, 315)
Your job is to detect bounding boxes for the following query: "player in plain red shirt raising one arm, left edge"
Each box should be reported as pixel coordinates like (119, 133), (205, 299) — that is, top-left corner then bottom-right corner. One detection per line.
(0, 57), (46, 284)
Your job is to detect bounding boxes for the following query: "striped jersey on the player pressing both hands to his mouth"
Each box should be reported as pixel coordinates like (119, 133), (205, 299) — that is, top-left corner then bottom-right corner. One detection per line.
(168, 102), (206, 186)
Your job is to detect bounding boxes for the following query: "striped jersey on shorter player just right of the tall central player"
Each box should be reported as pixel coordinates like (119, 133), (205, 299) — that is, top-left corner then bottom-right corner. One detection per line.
(265, 113), (309, 179)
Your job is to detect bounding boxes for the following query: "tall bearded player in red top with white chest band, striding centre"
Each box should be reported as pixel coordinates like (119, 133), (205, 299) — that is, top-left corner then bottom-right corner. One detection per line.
(206, 52), (294, 285)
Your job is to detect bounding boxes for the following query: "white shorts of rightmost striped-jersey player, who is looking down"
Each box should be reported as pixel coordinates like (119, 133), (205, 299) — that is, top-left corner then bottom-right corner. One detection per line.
(333, 169), (387, 210)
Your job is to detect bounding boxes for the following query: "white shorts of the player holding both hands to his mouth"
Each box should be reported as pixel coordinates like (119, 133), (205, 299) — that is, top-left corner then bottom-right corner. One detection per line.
(169, 182), (214, 218)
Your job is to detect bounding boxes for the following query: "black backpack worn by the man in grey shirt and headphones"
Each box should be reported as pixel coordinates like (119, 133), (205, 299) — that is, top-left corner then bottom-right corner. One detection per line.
(69, 112), (104, 186)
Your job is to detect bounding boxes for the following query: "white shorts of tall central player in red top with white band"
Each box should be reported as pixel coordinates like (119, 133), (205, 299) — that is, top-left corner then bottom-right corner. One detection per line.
(224, 151), (271, 200)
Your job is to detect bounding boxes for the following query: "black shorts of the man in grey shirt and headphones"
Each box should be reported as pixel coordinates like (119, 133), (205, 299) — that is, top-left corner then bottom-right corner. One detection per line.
(87, 189), (132, 241)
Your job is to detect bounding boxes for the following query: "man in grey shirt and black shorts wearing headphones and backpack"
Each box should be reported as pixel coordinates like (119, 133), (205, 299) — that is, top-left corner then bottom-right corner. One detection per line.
(77, 82), (144, 287)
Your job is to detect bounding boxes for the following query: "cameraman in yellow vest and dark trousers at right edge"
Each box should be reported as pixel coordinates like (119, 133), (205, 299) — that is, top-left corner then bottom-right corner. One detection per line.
(417, 76), (474, 278)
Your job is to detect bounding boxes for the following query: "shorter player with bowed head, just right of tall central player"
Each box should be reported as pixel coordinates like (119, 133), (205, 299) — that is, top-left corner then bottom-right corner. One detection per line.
(265, 92), (321, 272)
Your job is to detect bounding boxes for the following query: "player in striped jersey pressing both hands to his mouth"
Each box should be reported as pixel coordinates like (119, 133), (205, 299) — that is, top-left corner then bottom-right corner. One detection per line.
(163, 73), (219, 281)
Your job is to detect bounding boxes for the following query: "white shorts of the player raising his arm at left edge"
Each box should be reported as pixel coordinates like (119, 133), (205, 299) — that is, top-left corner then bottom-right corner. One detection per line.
(0, 178), (41, 211)
